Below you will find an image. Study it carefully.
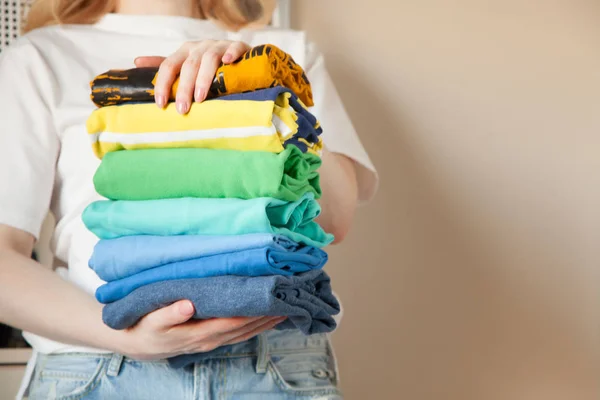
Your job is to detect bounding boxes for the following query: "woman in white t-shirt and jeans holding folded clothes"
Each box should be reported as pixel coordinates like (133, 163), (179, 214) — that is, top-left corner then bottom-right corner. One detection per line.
(0, 0), (376, 399)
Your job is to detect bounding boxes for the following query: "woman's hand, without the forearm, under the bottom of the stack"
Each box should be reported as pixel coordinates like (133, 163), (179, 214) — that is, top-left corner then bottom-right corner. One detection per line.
(118, 300), (286, 360)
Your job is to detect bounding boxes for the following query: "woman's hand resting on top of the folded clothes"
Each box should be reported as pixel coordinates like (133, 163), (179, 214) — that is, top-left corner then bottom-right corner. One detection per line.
(135, 40), (250, 114)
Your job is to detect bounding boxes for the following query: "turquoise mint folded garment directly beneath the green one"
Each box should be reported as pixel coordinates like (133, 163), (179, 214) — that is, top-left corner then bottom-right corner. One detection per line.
(82, 193), (333, 247)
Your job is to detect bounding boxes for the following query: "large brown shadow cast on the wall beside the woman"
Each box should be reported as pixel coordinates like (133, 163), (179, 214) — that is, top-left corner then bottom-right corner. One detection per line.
(314, 32), (589, 400)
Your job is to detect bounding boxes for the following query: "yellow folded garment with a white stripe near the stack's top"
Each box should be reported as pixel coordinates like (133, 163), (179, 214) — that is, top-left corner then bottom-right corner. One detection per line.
(87, 93), (322, 159)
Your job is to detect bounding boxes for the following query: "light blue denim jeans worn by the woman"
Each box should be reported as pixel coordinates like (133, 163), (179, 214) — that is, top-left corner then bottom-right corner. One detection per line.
(29, 331), (342, 400)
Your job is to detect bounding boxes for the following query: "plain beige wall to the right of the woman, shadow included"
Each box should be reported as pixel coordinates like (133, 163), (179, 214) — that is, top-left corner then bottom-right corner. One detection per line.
(293, 0), (600, 400)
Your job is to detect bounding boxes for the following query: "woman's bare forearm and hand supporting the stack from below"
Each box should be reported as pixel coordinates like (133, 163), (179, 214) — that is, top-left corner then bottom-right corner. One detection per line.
(0, 224), (285, 360)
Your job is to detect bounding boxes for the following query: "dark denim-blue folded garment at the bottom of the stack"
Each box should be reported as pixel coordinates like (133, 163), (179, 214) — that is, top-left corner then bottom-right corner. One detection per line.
(102, 270), (340, 335)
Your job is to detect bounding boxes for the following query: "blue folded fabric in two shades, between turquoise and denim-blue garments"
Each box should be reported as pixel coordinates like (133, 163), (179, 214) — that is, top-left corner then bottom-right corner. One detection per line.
(90, 235), (327, 303)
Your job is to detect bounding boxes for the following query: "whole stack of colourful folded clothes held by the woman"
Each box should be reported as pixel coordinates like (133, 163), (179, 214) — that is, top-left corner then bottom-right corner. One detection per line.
(83, 45), (339, 364)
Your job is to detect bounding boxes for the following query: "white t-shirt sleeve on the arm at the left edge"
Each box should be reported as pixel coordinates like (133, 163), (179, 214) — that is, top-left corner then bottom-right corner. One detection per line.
(0, 38), (60, 239)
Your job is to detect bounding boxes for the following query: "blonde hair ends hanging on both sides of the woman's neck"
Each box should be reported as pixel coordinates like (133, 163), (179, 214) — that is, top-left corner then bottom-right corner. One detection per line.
(23, 0), (275, 33)
